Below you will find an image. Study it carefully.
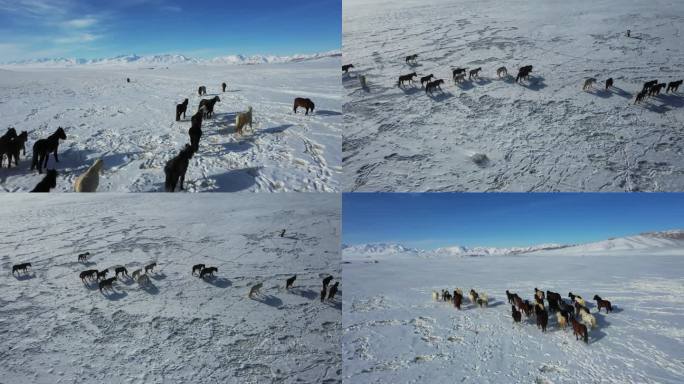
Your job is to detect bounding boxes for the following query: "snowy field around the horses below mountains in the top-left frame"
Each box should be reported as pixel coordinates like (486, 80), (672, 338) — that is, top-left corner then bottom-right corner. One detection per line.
(0, 57), (342, 192)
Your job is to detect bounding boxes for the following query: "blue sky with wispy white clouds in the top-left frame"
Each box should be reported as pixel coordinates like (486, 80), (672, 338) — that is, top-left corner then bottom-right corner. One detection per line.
(0, 0), (342, 62)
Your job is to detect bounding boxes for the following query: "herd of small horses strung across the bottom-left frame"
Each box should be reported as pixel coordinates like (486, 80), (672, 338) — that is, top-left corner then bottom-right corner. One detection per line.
(12, 236), (340, 302)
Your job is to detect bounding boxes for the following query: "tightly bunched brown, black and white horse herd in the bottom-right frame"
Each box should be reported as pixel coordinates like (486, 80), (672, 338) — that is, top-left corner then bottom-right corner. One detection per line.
(432, 287), (613, 343)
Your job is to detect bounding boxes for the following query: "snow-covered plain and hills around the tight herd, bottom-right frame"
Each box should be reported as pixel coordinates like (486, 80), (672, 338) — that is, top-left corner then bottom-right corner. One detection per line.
(342, 232), (684, 384)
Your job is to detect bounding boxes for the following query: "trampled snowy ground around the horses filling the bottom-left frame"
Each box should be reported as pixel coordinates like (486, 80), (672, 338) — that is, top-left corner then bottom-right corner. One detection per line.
(0, 194), (342, 384)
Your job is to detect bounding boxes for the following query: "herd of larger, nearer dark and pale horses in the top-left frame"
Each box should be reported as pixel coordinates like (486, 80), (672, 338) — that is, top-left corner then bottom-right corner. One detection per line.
(0, 78), (315, 192)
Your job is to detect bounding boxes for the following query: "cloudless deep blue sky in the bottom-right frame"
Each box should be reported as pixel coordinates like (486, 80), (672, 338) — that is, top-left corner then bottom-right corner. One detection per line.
(342, 193), (684, 249)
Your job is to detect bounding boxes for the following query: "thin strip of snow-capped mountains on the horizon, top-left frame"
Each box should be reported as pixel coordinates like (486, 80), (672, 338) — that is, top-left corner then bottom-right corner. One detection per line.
(0, 51), (342, 67)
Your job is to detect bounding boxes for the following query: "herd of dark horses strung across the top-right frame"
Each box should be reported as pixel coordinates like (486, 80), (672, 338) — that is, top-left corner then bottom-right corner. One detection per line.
(342, 54), (682, 104)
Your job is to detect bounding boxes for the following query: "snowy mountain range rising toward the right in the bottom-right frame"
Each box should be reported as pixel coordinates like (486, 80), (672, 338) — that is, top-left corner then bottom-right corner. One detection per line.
(342, 230), (684, 259)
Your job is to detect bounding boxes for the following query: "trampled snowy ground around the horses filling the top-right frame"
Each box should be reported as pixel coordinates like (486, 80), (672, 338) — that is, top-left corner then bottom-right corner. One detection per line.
(342, 0), (684, 191)
